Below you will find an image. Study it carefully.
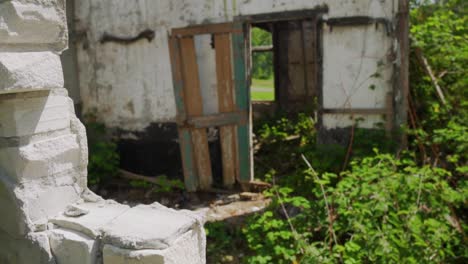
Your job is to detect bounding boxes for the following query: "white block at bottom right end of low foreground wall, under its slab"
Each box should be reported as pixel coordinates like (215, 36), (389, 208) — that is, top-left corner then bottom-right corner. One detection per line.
(103, 230), (206, 264)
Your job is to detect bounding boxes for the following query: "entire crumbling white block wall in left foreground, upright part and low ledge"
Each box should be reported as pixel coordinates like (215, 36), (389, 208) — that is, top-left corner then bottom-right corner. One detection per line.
(0, 0), (205, 264)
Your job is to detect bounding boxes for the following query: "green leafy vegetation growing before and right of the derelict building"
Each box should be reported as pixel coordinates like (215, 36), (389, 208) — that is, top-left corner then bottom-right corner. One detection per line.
(207, 0), (468, 263)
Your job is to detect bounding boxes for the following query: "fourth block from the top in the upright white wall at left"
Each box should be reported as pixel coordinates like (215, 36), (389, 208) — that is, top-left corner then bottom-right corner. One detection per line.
(0, 135), (81, 182)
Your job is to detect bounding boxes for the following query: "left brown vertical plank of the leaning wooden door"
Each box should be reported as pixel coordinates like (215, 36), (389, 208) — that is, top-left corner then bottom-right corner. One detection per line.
(180, 37), (213, 190)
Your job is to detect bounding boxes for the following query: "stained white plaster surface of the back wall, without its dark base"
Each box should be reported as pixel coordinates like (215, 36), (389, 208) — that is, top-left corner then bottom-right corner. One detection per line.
(76, 0), (398, 131)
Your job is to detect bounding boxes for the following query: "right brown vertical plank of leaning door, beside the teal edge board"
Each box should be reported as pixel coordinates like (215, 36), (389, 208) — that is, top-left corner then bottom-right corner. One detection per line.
(215, 34), (237, 187)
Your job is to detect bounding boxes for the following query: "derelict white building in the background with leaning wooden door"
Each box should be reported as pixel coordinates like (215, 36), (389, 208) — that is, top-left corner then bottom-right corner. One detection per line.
(63, 0), (406, 190)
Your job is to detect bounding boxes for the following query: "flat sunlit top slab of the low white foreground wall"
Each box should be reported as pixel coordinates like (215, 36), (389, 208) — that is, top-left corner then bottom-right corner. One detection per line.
(49, 199), (204, 250)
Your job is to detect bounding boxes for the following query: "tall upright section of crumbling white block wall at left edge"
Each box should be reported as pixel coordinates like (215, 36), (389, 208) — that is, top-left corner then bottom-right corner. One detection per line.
(0, 0), (87, 263)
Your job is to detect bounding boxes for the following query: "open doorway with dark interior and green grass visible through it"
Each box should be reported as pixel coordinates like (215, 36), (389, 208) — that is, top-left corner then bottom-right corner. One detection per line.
(247, 11), (323, 120)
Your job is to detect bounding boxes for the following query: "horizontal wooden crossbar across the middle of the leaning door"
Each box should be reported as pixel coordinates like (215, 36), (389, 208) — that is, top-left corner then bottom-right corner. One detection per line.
(187, 112), (248, 128)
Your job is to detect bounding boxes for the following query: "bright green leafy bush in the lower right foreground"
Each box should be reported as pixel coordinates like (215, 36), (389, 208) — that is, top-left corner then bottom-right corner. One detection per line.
(244, 153), (468, 263)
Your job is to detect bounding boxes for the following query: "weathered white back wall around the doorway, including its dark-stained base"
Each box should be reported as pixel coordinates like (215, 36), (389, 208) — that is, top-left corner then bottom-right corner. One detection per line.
(68, 0), (404, 175)
